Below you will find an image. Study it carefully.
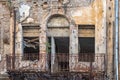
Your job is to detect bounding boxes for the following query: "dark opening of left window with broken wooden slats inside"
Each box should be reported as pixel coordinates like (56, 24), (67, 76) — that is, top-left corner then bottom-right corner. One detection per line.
(23, 37), (39, 61)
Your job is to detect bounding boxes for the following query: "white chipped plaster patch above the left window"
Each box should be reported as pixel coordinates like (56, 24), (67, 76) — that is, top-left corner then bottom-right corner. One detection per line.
(19, 4), (30, 22)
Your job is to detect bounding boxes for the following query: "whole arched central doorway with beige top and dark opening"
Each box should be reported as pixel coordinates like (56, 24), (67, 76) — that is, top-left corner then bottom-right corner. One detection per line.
(47, 14), (69, 72)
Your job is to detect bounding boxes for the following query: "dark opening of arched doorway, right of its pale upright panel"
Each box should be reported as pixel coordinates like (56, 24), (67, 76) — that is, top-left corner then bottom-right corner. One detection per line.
(55, 37), (69, 71)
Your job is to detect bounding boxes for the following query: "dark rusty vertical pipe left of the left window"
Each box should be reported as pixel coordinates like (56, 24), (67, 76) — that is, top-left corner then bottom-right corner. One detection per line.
(12, 8), (16, 69)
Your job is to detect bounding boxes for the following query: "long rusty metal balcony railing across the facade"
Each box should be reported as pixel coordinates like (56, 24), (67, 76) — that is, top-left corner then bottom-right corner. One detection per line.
(6, 53), (106, 80)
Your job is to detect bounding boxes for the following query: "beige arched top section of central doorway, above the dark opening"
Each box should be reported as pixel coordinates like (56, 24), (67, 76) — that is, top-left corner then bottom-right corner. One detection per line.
(47, 14), (69, 37)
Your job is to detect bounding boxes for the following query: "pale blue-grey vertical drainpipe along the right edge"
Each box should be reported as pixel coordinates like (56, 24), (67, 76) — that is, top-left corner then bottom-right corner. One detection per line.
(114, 0), (119, 80)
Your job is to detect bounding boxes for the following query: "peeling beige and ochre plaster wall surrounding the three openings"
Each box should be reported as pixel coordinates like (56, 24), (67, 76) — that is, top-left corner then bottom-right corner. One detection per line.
(0, 0), (106, 71)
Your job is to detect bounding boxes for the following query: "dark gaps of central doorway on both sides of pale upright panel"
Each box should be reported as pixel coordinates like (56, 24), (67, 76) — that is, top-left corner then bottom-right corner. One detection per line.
(47, 37), (69, 71)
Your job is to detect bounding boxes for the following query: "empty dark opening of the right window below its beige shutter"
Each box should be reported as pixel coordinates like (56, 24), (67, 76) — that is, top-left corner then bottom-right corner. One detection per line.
(78, 37), (95, 62)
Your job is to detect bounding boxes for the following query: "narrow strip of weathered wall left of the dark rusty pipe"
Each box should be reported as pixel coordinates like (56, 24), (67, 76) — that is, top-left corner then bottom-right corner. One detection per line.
(0, 2), (10, 74)
